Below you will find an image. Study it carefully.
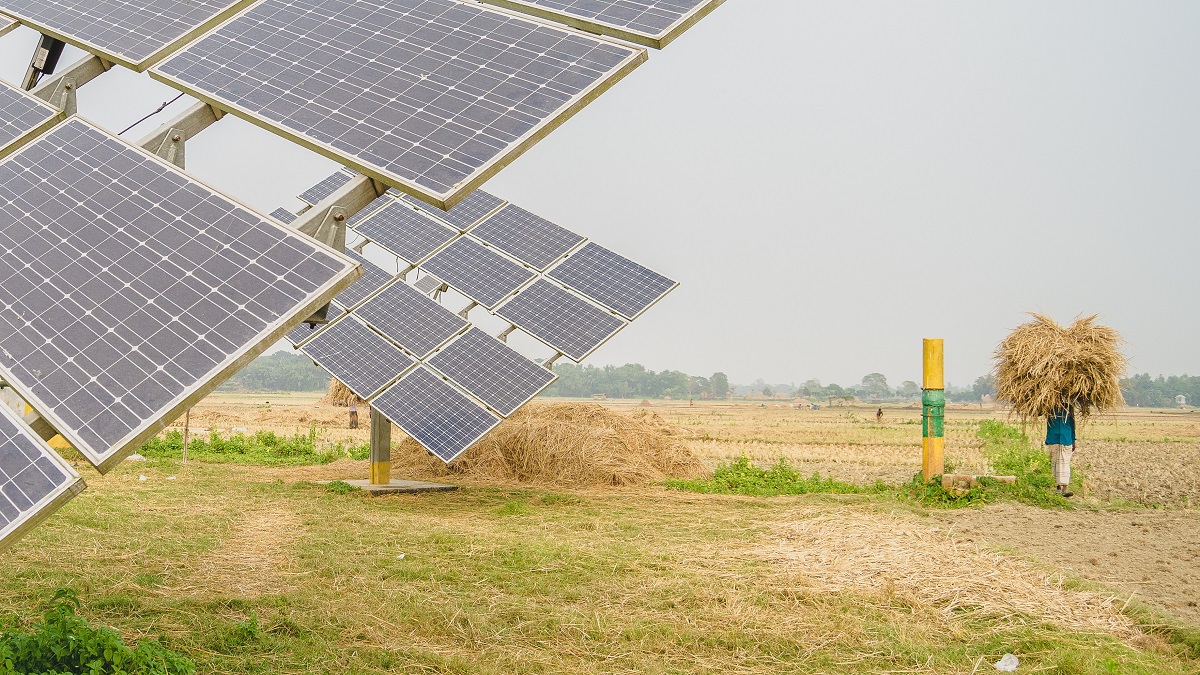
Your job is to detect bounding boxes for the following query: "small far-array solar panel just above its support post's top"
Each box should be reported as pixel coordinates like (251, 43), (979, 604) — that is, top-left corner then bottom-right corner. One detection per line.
(300, 317), (416, 399)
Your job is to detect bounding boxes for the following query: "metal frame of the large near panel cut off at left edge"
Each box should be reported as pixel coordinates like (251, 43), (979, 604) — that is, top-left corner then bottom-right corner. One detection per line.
(0, 117), (362, 473)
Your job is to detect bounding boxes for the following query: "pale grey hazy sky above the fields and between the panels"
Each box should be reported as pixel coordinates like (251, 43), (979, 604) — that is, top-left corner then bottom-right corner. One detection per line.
(0, 0), (1200, 384)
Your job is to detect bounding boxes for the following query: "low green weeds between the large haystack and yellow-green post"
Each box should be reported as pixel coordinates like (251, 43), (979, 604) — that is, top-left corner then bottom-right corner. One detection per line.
(666, 456), (892, 496)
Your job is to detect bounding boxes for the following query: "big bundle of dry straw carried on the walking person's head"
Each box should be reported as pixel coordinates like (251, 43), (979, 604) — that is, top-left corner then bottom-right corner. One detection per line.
(995, 313), (1126, 420)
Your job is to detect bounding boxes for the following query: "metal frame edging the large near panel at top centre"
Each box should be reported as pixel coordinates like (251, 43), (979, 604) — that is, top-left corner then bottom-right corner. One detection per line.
(149, 0), (648, 210)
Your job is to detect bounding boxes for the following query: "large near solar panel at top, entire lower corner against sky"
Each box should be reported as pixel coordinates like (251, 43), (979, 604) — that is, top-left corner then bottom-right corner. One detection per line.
(154, 0), (646, 208)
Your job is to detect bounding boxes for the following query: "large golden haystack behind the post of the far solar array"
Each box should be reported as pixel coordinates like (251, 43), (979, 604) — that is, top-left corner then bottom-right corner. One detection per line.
(392, 402), (707, 486)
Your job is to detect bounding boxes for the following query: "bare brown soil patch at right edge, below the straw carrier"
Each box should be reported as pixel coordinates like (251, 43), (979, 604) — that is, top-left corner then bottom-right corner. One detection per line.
(931, 503), (1200, 626)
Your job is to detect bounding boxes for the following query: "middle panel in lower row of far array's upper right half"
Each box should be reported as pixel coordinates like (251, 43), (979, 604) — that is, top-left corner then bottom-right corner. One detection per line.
(421, 237), (534, 309)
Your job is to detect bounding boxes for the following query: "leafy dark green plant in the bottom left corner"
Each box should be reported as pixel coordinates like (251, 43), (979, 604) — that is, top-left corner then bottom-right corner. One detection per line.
(0, 589), (196, 675)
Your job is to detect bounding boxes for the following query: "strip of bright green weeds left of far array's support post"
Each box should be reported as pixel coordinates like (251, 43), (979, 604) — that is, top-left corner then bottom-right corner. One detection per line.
(138, 426), (371, 466)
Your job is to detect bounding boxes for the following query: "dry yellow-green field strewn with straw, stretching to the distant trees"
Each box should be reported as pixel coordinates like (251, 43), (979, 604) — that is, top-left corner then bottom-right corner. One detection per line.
(0, 395), (1200, 674)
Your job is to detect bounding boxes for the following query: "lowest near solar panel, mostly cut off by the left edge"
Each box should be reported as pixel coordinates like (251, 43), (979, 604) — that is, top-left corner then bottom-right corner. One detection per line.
(0, 396), (84, 549)
